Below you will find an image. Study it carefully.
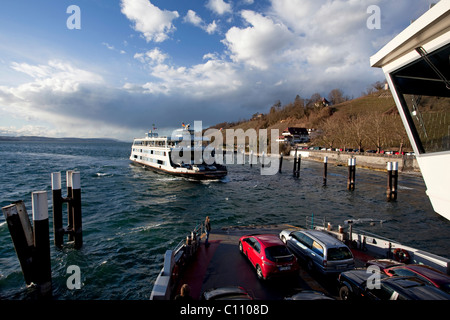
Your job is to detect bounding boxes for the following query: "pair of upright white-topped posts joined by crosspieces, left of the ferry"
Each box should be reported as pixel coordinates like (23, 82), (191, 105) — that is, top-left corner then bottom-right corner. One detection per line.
(52, 170), (83, 249)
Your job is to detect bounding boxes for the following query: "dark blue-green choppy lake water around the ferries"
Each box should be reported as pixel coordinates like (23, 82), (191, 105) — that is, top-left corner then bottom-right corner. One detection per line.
(0, 142), (450, 300)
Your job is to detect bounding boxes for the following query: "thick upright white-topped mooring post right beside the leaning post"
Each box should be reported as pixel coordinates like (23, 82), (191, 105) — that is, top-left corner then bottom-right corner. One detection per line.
(31, 191), (52, 297)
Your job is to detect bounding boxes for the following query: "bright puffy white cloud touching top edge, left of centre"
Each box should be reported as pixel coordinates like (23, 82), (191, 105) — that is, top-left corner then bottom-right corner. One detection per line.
(121, 0), (179, 42)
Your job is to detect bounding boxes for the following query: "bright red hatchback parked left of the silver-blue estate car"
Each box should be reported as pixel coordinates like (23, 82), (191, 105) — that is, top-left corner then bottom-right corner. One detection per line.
(239, 234), (298, 279)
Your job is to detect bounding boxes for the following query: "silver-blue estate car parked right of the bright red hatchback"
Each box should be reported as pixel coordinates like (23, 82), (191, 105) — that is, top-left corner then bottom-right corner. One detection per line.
(280, 230), (355, 275)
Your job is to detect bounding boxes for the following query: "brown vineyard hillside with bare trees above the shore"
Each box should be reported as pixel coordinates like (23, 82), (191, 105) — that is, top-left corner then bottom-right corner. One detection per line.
(207, 89), (410, 151)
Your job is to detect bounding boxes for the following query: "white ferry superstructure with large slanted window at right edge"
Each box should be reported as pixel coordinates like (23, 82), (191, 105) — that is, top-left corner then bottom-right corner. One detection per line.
(370, 0), (450, 220)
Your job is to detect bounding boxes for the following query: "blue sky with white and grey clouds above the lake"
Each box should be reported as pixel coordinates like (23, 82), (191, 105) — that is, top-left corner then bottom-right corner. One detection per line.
(0, 0), (438, 141)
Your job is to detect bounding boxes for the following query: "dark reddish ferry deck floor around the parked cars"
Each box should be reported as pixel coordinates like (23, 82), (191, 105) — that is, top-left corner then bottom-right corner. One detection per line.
(176, 224), (373, 300)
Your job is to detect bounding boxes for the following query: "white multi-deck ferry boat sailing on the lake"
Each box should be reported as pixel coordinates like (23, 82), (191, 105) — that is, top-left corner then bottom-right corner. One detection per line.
(130, 125), (227, 180)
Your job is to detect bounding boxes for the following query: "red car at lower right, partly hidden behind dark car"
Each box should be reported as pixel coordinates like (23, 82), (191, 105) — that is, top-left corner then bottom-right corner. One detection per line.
(384, 264), (450, 293)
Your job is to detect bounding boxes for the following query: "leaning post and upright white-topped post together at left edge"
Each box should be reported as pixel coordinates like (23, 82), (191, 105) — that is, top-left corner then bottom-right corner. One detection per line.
(2, 191), (52, 298)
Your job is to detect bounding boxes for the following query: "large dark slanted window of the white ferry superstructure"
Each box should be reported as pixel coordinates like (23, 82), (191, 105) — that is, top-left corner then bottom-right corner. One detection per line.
(390, 44), (450, 153)
